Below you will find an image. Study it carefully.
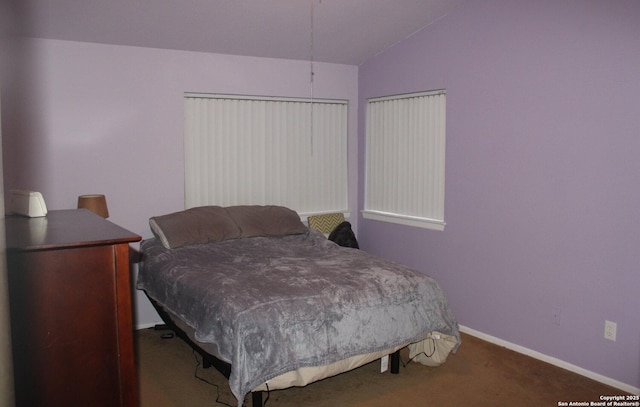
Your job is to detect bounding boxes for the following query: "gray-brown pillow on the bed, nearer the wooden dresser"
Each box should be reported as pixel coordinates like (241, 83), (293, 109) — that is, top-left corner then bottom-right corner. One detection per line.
(149, 206), (240, 249)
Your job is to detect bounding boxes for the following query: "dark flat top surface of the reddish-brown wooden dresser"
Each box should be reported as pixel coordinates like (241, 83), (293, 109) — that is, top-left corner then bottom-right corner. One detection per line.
(4, 209), (141, 251)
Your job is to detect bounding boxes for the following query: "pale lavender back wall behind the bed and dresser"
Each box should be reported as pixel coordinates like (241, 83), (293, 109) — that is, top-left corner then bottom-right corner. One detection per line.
(2, 40), (358, 325)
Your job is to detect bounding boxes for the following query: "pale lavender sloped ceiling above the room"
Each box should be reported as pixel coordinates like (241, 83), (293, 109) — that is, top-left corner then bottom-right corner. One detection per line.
(12, 0), (464, 65)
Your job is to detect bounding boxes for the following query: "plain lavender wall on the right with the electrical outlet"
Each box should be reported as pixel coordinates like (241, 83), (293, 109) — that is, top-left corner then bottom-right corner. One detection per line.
(359, 0), (640, 389)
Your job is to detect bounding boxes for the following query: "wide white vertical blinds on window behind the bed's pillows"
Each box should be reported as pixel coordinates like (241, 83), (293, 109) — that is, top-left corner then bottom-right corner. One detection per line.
(184, 94), (348, 215)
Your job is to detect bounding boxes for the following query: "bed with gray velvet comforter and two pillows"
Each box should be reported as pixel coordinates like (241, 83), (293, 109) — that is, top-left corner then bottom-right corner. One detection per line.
(137, 206), (460, 406)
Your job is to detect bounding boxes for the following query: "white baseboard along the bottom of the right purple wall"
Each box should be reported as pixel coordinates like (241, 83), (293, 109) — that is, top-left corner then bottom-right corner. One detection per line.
(460, 325), (640, 394)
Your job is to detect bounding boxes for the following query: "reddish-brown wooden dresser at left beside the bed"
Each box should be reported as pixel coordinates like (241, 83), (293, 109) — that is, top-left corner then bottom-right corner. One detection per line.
(5, 209), (140, 407)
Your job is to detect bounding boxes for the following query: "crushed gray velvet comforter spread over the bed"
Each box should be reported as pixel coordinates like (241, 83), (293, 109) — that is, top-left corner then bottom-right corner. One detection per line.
(137, 231), (459, 406)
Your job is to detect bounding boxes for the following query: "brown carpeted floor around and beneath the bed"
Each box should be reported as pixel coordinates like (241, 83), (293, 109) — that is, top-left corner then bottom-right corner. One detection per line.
(136, 329), (623, 407)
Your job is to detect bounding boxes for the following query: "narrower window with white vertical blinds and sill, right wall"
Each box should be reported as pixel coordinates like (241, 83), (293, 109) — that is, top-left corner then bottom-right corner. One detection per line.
(363, 90), (446, 230)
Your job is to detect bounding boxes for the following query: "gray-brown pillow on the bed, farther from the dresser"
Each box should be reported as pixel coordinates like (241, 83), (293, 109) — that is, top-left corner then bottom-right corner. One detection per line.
(226, 205), (308, 237)
